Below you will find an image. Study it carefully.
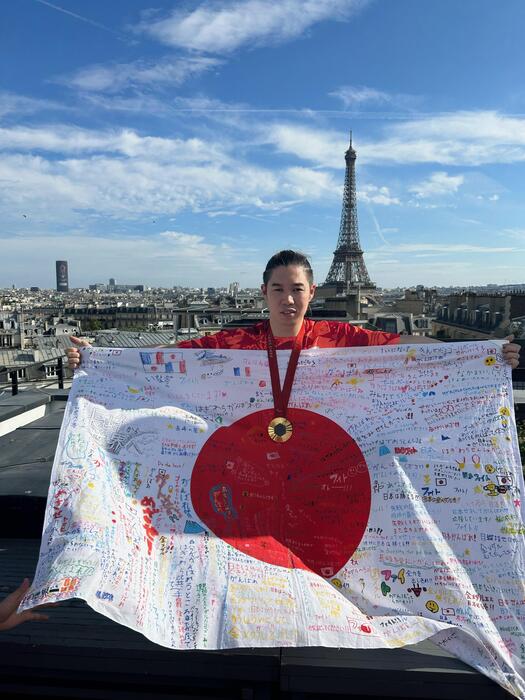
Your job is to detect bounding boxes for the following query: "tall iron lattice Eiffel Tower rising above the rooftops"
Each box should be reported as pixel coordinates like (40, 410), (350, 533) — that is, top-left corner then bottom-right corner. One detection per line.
(325, 132), (375, 292)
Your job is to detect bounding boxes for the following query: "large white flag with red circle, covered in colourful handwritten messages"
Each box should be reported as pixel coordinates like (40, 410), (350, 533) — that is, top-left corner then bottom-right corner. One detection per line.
(23, 341), (525, 697)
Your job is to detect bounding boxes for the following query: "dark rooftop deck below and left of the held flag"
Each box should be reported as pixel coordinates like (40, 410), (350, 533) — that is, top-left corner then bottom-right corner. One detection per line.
(0, 391), (511, 700)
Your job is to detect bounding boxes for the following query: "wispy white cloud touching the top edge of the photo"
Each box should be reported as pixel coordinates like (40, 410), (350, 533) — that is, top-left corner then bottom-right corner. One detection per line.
(136, 0), (368, 53)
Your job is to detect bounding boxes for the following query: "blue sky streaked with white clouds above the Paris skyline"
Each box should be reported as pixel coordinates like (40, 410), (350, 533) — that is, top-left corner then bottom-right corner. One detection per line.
(0, 0), (525, 287)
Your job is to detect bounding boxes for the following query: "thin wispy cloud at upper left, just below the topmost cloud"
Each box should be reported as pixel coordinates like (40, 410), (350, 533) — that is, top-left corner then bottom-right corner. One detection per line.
(56, 56), (222, 94)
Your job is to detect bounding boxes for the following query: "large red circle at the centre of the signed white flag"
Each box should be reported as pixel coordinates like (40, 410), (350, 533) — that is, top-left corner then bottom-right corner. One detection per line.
(191, 408), (371, 578)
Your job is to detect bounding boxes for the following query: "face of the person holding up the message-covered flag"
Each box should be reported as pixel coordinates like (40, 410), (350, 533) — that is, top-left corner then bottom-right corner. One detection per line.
(261, 265), (315, 336)
